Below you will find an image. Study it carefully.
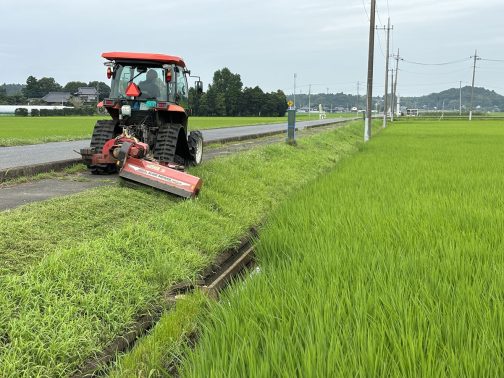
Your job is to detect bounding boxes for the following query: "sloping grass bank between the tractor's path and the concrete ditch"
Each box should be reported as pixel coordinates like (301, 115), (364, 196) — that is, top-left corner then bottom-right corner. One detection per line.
(0, 122), (370, 376)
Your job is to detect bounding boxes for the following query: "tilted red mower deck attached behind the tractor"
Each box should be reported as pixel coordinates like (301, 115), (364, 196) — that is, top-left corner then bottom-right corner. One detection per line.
(119, 157), (203, 198)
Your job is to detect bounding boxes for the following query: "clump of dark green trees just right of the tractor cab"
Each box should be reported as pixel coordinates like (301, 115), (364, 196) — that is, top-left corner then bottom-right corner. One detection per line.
(189, 68), (287, 117)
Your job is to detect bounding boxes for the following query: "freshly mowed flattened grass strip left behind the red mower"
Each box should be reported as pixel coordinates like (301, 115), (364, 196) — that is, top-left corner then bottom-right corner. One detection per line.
(0, 185), (177, 276)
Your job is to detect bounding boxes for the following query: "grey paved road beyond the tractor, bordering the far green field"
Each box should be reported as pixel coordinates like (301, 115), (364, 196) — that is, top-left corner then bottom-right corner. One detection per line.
(0, 118), (354, 170)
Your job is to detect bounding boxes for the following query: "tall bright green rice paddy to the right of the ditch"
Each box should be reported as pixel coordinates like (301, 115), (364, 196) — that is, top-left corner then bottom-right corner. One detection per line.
(181, 121), (504, 377)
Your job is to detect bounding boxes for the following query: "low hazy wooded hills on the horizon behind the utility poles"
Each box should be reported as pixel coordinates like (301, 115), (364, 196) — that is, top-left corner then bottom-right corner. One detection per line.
(287, 86), (504, 111)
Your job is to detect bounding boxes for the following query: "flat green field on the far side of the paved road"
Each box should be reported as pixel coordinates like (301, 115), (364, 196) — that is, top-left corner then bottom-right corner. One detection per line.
(0, 114), (348, 147)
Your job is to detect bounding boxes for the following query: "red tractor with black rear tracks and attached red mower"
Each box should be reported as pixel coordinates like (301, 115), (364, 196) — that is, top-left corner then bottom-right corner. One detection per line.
(81, 52), (203, 197)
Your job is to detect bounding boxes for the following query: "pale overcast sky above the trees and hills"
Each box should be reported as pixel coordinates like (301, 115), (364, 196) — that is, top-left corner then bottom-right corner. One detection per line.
(0, 0), (504, 96)
